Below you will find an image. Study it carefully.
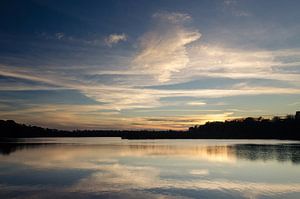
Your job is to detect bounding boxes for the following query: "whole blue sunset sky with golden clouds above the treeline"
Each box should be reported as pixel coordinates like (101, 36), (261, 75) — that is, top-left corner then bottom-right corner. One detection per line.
(0, 0), (300, 130)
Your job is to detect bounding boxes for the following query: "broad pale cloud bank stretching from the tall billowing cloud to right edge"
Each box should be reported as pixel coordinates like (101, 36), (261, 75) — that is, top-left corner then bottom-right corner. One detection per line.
(182, 44), (300, 83)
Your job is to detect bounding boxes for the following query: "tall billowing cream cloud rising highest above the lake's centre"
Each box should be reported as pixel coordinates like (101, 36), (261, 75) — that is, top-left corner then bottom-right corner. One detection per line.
(132, 10), (201, 82)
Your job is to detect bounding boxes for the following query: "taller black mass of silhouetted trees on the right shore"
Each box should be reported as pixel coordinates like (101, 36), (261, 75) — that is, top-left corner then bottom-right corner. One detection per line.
(189, 115), (300, 140)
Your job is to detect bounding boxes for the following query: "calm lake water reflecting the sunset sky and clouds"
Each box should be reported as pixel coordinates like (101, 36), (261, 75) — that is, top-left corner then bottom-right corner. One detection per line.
(0, 138), (300, 199)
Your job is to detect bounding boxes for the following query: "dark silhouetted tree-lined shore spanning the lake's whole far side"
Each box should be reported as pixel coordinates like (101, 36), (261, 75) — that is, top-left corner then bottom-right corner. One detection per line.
(0, 112), (300, 140)
